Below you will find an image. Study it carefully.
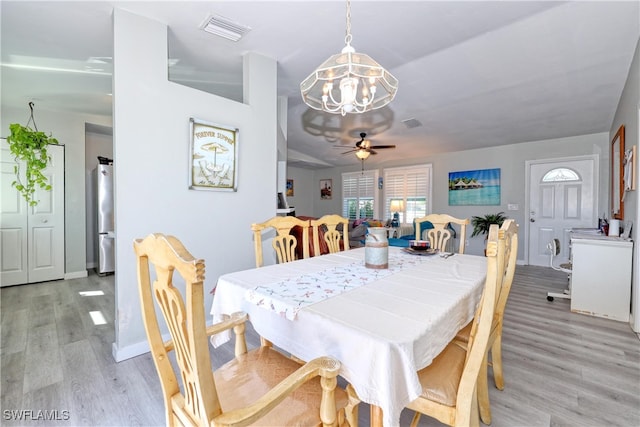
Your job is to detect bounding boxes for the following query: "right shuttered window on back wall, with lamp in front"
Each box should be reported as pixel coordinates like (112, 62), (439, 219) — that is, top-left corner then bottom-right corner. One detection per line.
(384, 164), (431, 224)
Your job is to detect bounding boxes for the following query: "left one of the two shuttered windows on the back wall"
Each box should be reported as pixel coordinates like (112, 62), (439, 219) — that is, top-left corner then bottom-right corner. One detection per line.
(342, 170), (378, 219)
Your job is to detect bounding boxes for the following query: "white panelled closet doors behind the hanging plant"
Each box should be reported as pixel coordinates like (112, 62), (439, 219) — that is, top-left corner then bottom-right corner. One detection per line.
(0, 140), (64, 286)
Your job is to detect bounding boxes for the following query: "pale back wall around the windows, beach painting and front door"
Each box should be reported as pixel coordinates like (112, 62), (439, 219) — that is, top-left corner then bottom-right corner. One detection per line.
(290, 132), (609, 259)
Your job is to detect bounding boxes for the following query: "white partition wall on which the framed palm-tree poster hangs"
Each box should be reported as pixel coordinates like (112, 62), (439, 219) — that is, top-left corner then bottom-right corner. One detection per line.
(113, 9), (277, 360)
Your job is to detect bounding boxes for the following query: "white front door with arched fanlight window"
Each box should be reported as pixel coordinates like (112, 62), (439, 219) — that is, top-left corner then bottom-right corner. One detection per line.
(528, 156), (598, 266)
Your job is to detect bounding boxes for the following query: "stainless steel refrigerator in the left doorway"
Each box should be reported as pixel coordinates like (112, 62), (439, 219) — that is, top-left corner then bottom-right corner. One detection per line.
(93, 157), (116, 275)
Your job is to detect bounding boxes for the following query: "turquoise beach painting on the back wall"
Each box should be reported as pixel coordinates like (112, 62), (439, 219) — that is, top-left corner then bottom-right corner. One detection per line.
(449, 169), (500, 206)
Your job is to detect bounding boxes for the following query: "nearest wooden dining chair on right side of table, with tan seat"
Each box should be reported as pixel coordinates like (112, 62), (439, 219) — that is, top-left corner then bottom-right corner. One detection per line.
(407, 224), (505, 427)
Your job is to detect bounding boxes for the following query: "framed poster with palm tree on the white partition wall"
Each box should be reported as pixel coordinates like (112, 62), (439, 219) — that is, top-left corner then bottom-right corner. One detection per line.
(189, 118), (238, 191)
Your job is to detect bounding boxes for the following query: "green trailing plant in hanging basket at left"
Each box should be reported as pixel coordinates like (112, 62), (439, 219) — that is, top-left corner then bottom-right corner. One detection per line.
(7, 102), (58, 206)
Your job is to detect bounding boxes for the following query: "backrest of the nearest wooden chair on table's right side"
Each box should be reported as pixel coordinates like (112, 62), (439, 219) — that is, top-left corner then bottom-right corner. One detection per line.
(455, 224), (506, 425)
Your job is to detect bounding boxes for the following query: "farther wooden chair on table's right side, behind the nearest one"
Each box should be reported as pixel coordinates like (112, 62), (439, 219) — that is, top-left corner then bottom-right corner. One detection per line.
(455, 219), (518, 424)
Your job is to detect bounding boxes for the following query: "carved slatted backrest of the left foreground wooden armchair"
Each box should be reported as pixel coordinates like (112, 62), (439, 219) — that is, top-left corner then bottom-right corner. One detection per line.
(133, 234), (221, 425)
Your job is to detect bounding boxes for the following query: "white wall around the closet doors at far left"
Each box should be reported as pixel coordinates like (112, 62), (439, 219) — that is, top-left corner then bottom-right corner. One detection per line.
(2, 104), (111, 279)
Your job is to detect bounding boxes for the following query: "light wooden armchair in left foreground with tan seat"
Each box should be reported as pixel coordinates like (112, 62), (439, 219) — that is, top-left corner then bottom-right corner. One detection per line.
(134, 234), (357, 426)
